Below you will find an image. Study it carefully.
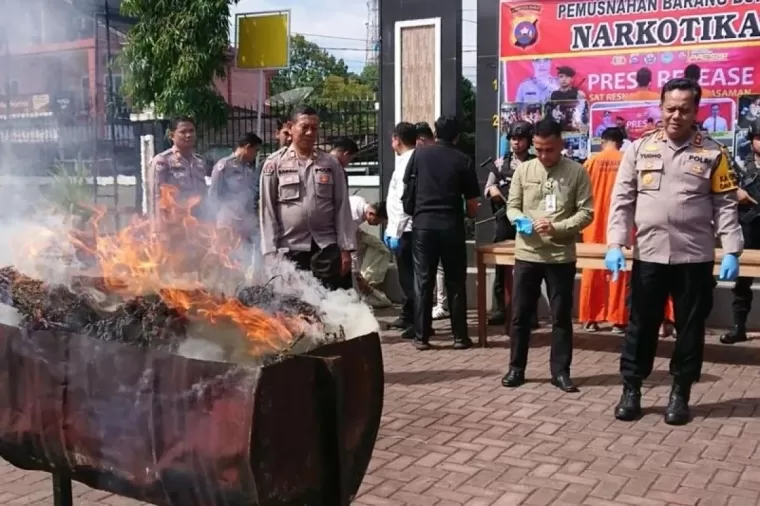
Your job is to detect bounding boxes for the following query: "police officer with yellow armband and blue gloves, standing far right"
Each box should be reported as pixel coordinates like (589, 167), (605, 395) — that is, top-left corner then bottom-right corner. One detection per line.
(605, 78), (744, 425)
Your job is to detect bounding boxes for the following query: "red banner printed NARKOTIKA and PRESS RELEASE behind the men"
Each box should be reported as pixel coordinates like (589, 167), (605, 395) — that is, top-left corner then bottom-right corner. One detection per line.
(499, 0), (760, 156)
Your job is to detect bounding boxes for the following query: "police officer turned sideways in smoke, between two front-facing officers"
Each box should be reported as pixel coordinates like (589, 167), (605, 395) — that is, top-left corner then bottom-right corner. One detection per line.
(209, 132), (261, 243)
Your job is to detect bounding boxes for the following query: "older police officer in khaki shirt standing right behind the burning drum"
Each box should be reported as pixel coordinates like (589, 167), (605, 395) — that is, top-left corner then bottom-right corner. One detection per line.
(260, 106), (356, 289)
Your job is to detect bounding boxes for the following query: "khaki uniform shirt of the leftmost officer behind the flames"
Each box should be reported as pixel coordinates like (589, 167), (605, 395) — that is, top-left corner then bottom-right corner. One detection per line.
(146, 147), (207, 223)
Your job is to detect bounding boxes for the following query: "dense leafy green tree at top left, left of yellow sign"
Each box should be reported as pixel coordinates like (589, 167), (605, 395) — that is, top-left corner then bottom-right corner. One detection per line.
(120, 0), (232, 126)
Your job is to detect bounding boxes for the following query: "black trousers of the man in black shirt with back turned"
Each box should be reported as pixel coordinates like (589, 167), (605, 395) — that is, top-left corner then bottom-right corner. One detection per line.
(412, 227), (469, 342)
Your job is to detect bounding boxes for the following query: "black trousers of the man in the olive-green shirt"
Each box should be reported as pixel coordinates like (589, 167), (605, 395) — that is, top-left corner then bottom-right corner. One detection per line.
(509, 260), (575, 377)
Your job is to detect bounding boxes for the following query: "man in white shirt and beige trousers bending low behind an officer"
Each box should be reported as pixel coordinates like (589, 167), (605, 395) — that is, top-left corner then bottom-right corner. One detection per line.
(348, 195), (391, 308)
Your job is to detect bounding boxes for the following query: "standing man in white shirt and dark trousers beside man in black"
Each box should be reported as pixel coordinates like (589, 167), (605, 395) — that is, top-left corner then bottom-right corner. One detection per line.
(385, 122), (417, 339)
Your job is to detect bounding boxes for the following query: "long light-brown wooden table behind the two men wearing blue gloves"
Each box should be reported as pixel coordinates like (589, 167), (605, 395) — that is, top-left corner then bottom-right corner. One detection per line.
(476, 241), (760, 347)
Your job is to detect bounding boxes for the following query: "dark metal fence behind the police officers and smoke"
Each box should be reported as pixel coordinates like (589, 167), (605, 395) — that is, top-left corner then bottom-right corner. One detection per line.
(0, 101), (378, 175)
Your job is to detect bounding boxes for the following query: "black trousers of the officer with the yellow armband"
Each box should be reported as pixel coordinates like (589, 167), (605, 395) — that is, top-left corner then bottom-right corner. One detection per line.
(620, 260), (716, 384)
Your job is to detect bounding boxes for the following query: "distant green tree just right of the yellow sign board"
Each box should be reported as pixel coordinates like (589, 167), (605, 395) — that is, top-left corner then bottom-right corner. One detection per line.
(270, 35), (349, 98)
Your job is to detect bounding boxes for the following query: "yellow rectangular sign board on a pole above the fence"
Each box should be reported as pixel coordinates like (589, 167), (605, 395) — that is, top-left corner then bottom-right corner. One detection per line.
(235, 11), (290, 70)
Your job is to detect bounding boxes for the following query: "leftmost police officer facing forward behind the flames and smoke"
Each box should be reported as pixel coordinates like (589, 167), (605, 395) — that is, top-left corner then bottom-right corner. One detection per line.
(146, 116), (207, 229)
